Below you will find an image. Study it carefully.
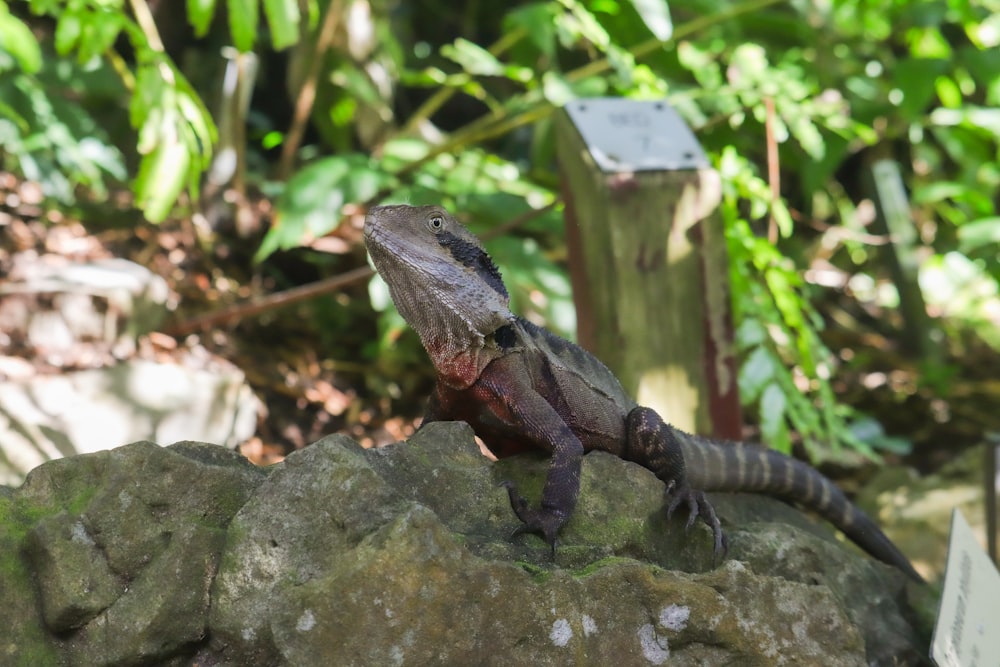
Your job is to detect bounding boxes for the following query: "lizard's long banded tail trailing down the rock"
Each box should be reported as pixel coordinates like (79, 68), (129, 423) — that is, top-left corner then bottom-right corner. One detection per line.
(680, 434), (923, 581)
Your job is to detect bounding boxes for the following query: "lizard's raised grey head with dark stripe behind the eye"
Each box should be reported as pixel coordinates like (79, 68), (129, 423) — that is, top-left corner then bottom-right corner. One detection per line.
(365, 205), (514, 337)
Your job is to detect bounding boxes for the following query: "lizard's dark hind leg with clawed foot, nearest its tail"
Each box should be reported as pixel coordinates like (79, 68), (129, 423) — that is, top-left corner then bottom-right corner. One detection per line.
(624, 407), (727, 557)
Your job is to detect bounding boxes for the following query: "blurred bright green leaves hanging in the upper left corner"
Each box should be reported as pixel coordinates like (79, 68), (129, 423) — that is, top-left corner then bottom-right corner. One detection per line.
(0, 0), (300, 222)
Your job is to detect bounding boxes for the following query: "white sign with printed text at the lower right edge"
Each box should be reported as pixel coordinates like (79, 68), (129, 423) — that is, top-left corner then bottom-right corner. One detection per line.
(931, 509), (1000, 667)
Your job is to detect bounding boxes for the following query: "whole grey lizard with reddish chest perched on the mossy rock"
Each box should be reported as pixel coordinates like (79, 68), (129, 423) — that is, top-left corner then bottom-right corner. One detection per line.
(363, 205), (922, 581)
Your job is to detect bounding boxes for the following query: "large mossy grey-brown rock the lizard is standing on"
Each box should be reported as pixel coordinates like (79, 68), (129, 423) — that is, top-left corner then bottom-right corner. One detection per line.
(0, 424), (926, 666)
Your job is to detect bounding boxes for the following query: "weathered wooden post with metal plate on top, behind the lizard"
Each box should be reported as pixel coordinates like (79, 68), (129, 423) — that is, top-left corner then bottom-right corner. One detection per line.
(556, 98), (741, 438)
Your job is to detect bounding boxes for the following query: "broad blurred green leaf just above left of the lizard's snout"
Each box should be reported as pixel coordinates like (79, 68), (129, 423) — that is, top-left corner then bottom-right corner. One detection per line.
(255, 154), (394, 261)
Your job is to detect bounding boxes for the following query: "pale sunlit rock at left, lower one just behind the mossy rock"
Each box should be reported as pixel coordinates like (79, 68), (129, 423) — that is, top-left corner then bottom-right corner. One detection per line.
(0, 359), (258, 484)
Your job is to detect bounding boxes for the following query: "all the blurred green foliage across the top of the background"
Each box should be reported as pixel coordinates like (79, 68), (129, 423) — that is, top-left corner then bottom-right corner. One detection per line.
(0, 0), (1000, 456)
